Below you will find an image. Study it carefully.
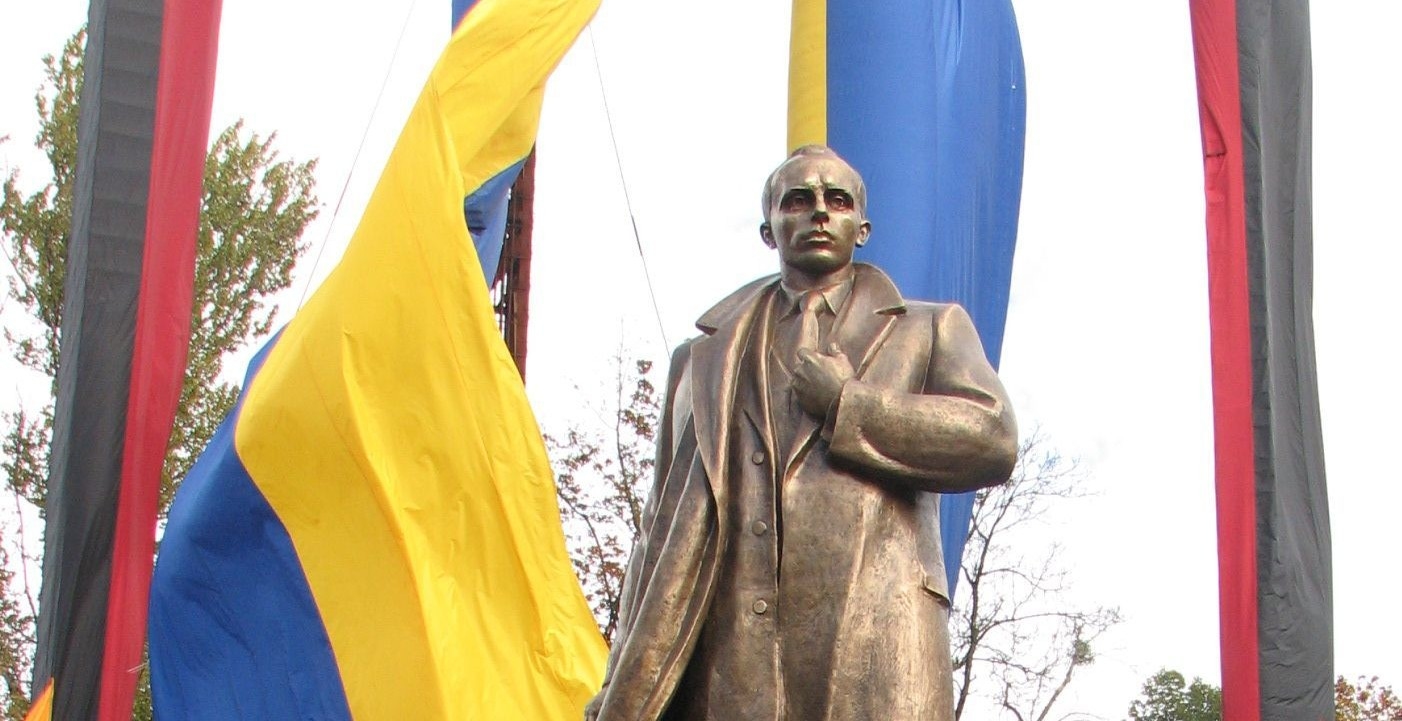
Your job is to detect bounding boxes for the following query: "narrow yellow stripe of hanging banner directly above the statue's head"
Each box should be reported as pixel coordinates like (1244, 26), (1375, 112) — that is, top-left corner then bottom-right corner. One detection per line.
(788, 0), (827, 151)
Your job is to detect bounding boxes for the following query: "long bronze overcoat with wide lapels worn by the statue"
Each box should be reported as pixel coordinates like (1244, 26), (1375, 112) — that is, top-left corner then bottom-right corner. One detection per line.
(590, 264), (1016, 721)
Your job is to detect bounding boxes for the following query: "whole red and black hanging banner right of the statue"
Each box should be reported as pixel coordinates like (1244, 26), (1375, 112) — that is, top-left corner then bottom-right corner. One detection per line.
(1192, 0), (1333, 712)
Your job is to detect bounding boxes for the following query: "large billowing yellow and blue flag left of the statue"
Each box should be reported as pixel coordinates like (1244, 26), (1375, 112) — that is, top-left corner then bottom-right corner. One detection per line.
(150, 0), (606, 720)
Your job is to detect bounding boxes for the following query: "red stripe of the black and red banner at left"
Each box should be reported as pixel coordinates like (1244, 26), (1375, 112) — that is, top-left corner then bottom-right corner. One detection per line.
(98, 0), (222, 712)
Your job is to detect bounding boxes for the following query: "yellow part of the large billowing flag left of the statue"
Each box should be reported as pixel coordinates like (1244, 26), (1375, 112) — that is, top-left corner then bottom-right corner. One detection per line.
(236, 0), (606, 721)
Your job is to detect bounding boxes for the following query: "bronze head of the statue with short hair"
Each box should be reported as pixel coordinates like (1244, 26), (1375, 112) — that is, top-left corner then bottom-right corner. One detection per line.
(760, 144), (872, 281)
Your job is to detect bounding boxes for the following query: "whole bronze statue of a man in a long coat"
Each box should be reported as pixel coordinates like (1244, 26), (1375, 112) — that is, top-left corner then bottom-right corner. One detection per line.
(586, 146), (1016, 721)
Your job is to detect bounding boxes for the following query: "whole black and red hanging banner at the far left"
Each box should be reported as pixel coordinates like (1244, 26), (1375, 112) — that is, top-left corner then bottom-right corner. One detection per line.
(31, 0), (220, 721)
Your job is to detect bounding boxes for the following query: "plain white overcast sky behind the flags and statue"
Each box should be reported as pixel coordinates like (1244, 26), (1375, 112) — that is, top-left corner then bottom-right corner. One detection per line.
(0, 0), (1402, 709)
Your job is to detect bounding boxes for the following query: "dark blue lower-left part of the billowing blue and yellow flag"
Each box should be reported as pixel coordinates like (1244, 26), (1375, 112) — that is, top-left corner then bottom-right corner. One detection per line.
(147, 338), (351, 721)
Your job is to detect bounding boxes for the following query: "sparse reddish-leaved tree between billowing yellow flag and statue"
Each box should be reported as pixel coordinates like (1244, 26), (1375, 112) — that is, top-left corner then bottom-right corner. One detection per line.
(545, 353), (660, 641)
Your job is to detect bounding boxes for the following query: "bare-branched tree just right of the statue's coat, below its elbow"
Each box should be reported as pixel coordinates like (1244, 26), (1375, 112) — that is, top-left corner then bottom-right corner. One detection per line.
(949, 433), (1120, 721)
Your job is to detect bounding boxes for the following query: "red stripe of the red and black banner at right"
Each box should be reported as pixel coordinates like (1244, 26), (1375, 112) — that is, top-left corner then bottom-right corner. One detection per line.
(1190, 0), (1260, 721)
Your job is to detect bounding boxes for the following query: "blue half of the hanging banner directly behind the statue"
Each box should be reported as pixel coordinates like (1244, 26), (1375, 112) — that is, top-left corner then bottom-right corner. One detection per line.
(827, 0), (1026, 593)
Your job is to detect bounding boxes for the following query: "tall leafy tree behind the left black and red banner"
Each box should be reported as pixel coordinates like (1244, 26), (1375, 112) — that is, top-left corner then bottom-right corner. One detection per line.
(0, 29), (318, 718)
